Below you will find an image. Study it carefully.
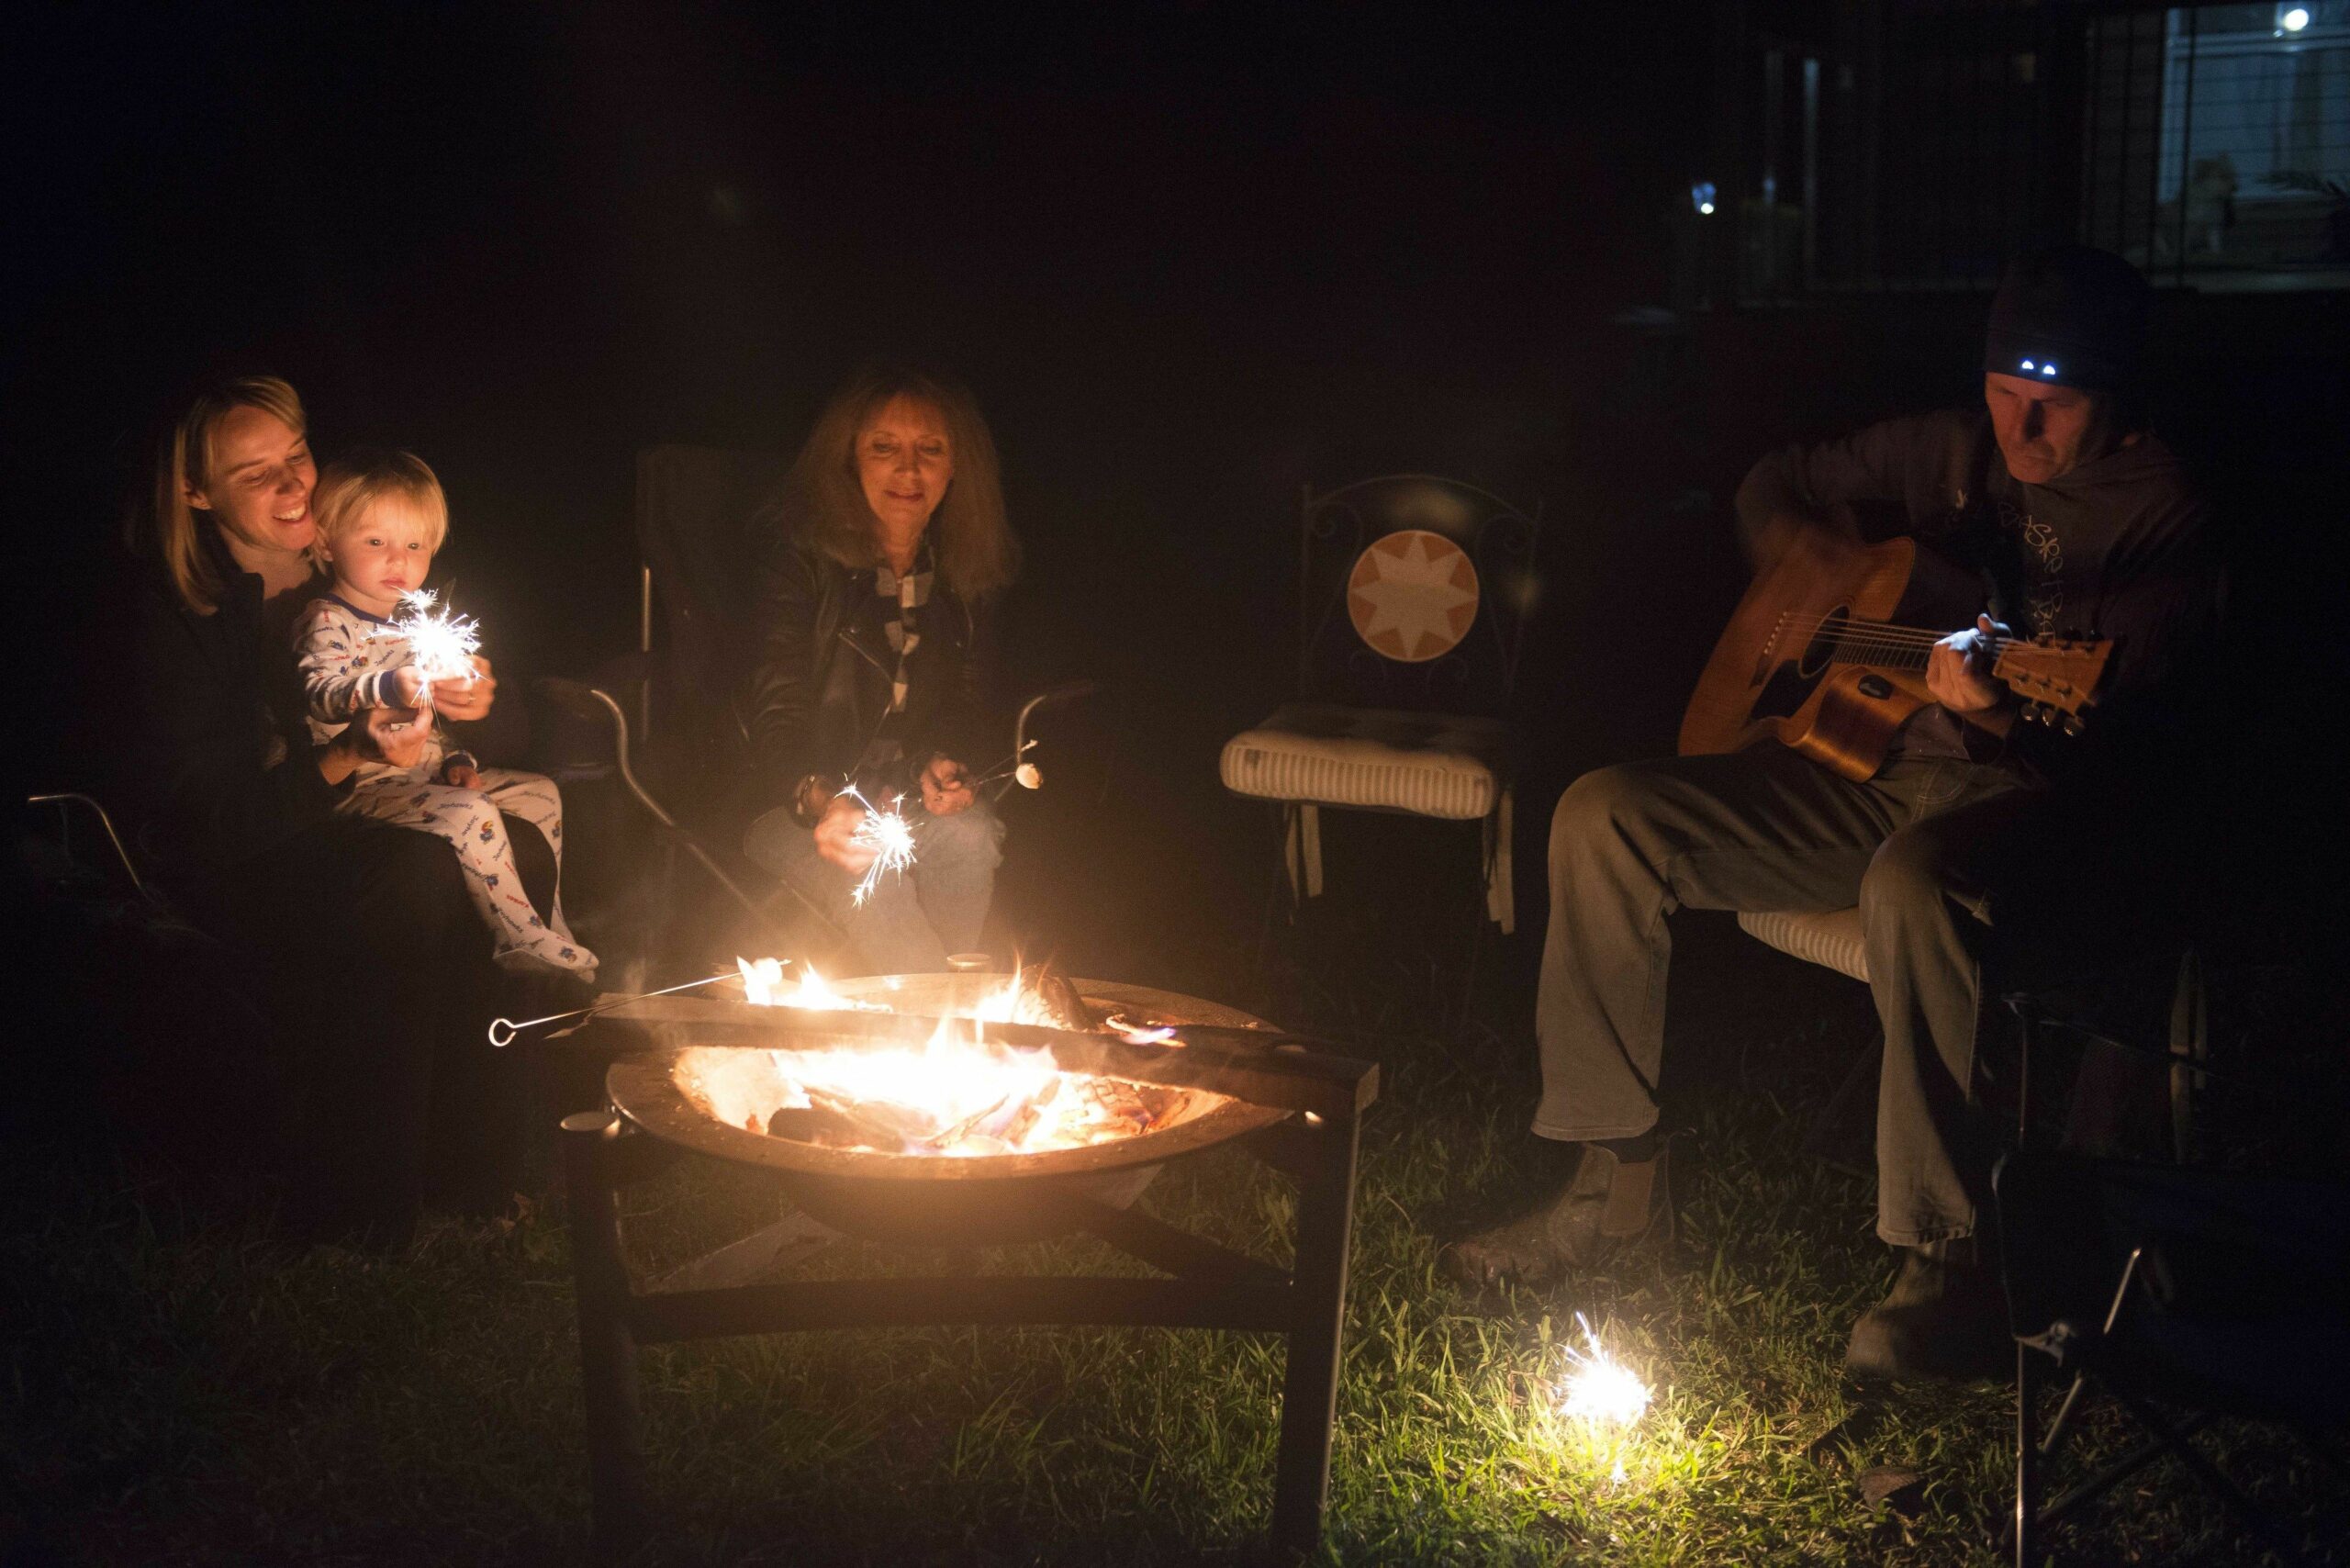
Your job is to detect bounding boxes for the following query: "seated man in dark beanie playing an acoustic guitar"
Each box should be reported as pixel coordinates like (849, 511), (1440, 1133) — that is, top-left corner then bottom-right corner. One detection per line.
(1448, 247), (2221, 1378)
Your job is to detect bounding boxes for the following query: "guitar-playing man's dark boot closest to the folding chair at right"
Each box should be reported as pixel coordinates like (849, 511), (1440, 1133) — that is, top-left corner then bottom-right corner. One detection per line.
(1845, 1237), (2016, 1383)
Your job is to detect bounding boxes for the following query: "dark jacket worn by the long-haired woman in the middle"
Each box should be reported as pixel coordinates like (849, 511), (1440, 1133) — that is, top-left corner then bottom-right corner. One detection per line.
(735, 532), (991, 811)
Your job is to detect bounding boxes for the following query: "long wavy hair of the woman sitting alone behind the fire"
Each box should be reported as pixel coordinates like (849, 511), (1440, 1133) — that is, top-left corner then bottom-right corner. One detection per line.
(759, 366), (1020, 599)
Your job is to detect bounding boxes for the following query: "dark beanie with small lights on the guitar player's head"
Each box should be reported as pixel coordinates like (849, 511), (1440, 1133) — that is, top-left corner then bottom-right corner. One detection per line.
(1984, 244), (2155, 393)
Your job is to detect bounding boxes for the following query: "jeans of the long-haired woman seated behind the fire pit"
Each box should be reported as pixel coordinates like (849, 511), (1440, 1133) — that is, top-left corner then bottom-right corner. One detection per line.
(743, 801), (1003, 976)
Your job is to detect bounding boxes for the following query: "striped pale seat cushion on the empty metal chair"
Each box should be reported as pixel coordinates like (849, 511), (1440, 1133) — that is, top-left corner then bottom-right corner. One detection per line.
(1220, 703), (1509, 823)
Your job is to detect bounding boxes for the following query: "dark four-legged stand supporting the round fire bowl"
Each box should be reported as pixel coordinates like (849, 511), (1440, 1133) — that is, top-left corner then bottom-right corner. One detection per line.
(562, 987), (1377, 1561)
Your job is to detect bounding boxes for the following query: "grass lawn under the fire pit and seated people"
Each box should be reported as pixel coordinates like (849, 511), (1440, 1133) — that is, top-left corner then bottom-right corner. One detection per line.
(0, 912), (2350, 1563)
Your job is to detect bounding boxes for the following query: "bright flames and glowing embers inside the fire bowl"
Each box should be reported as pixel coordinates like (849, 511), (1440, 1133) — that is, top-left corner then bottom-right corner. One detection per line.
(677, 959), (1225, 1159)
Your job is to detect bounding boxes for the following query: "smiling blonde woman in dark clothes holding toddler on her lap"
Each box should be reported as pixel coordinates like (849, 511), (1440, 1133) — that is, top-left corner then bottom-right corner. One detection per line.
(110, 376), (545, 1246)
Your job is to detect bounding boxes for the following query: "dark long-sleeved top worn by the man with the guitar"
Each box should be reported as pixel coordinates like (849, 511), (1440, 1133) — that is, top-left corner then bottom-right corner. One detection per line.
(1737, 409), (2223, 776)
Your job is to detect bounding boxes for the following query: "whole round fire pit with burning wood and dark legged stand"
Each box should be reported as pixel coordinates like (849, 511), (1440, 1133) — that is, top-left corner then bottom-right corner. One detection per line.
(564, 973), (1377, 1559)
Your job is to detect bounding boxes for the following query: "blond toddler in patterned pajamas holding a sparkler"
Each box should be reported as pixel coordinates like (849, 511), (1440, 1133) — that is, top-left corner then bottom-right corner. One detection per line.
(294, 452), (597, 978)
